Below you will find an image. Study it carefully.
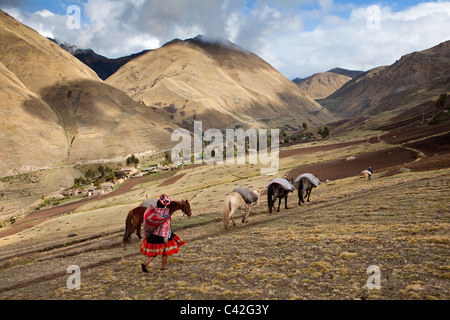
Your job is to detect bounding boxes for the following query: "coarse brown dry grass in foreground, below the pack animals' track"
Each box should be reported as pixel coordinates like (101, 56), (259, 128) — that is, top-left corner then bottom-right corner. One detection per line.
(2, 171), (450, 300)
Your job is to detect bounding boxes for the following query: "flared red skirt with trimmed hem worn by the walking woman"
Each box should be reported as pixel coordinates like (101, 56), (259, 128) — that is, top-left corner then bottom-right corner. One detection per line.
(140, 233), (186, 257)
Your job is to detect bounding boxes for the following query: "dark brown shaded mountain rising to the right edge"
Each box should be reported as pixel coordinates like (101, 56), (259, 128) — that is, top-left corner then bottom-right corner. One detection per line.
(318, 41), (450, 118)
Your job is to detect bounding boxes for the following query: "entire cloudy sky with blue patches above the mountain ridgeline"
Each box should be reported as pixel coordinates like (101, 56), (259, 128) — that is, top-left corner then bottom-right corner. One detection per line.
(0, 0), (450, 80)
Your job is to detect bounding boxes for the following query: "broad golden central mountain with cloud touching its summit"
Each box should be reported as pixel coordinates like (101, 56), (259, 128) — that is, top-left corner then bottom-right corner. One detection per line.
(106, 36), (335, 129)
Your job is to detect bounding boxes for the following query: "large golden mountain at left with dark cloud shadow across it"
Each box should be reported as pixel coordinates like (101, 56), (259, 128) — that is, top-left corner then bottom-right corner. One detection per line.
(0, 11), (174, 175)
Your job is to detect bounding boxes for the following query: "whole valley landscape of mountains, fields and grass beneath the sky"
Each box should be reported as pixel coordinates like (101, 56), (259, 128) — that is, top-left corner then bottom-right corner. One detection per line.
(0, 10), (450, 300)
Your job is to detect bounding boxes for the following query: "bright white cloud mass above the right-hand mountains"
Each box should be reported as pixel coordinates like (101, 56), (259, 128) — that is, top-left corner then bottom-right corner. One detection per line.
(255, 2), (450, 79)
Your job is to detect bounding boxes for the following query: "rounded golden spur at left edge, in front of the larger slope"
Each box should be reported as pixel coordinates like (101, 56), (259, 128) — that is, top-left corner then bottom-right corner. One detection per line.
(0, 63), (67, 176)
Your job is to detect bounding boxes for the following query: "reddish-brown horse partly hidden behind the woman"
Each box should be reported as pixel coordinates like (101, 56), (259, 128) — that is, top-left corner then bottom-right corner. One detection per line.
(123, 200), (192, 245)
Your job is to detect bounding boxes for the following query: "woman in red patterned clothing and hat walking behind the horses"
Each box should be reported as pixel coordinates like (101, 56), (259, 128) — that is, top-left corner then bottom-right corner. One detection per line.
(140, 194), (186, 272)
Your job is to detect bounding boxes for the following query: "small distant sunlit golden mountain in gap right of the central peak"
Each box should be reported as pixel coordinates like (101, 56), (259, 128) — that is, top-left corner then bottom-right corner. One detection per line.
(294, 68), (362, 99)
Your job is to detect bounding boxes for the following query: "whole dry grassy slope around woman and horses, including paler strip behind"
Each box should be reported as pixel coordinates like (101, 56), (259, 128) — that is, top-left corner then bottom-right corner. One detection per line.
(0, 138), (450, 300)
